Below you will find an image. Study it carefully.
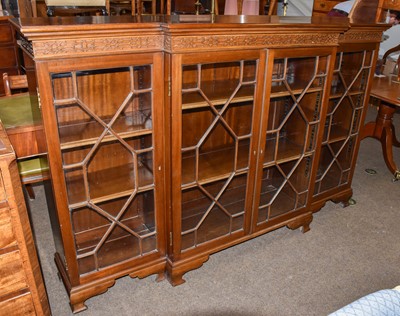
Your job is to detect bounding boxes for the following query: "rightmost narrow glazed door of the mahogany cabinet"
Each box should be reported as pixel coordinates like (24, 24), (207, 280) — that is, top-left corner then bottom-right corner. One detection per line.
(314, 44), (376, 203)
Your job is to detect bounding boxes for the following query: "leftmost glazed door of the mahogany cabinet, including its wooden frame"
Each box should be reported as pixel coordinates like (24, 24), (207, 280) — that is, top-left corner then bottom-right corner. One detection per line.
(37, 53), (165, 286)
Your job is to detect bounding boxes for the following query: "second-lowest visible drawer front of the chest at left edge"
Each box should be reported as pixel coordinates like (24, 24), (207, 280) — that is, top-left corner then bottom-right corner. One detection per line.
(0, 251), (28, 297)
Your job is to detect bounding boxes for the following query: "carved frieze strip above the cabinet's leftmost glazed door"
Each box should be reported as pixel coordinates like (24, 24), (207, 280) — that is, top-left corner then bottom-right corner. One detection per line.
(33, 35), (164, 58)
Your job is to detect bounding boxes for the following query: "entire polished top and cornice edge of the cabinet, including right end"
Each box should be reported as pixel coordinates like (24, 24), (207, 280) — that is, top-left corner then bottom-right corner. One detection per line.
(12, 15), (386, 39)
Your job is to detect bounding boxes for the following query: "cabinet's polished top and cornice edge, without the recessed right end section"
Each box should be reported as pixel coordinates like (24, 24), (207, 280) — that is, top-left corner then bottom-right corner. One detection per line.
(13, 15), (349, 33)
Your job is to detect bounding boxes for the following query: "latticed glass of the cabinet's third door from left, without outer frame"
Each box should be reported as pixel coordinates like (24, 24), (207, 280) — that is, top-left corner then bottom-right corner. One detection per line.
(257, 56), (329, 224)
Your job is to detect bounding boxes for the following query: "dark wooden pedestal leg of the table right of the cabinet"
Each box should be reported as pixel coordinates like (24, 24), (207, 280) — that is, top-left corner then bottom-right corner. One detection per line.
(361, 102), (400, 180)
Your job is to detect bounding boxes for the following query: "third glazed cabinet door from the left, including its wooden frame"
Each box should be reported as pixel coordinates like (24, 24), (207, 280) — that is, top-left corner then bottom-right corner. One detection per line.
(254, 48), (334, 231)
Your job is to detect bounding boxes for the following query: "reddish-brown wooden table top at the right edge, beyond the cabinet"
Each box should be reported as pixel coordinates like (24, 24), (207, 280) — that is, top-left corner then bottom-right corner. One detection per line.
(371, 76), (400, 107)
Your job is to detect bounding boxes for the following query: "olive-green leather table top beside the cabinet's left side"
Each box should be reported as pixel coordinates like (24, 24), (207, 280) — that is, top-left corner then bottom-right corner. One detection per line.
(0, 93), (42, 129)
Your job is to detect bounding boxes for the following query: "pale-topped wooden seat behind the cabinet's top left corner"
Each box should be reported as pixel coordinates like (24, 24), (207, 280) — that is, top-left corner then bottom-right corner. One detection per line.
(45, 0), (110, 16)
